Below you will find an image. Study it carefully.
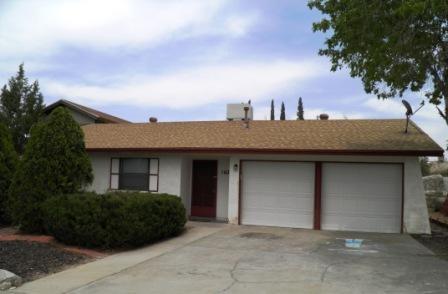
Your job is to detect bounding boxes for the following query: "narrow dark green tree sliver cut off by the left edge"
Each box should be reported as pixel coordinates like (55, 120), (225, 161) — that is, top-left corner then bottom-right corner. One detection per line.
(0, 123), (17, 223)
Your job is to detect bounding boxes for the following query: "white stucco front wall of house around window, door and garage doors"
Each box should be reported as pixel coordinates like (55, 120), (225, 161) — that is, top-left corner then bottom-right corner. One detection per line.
(89, 153), (430, 233)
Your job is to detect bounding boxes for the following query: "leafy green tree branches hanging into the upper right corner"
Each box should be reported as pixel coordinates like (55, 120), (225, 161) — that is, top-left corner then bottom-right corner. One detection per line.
(308, 0), (448, 124)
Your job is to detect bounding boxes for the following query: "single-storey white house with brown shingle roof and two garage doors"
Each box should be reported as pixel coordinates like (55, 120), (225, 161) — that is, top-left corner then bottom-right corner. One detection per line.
(83, 105), (443, 233)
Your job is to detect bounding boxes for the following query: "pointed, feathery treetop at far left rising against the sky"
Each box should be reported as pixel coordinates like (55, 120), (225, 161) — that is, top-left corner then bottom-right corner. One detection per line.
(0, 64), (44, 154)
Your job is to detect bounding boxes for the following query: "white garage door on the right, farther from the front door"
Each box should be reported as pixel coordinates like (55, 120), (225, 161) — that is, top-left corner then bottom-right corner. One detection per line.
(321, 163), (402, 233)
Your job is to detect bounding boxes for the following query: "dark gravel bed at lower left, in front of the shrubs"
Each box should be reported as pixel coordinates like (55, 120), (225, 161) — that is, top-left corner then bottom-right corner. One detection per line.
(0, 241), (89, 281)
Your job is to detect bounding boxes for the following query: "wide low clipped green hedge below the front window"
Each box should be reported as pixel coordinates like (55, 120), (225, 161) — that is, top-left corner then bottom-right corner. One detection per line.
(43, 193), (186, 248)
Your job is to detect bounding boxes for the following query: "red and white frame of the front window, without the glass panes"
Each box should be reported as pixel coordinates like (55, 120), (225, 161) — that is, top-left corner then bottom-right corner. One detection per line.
(109, 157), (160, 192)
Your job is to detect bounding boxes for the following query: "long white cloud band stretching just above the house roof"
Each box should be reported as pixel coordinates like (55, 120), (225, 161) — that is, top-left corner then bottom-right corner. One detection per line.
(41, 60), (328, 108)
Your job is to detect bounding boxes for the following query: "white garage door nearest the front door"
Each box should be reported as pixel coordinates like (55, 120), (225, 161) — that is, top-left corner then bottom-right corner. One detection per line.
(241, 161), (314, 228)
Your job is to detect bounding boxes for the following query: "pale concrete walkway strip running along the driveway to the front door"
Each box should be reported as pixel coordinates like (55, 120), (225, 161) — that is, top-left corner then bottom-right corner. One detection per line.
(11, 222), (228, 294)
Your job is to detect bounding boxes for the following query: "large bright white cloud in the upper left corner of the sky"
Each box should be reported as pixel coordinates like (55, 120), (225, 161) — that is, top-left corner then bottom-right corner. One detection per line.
(0, 0), (257, 61)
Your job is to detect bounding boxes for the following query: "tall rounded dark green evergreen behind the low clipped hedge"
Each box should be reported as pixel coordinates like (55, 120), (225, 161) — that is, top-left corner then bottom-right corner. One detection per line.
(10, 107), (93, 233)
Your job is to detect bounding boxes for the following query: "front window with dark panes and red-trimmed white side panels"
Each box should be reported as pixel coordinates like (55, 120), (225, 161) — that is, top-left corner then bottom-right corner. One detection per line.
(110, 157), (159, 192)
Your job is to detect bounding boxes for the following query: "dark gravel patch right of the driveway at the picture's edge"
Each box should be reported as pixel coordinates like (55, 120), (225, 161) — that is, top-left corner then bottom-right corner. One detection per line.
(412, 222), (448, 260)
